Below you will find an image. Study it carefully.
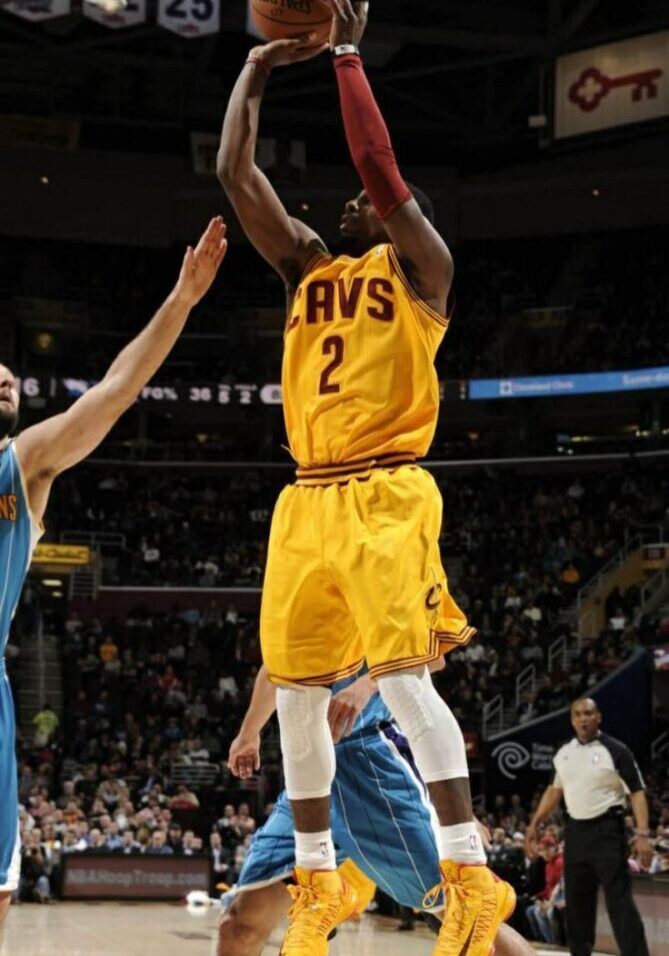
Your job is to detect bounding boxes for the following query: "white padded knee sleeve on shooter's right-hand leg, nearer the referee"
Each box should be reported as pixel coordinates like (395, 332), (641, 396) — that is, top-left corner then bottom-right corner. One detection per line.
(378, 667), (469, 783)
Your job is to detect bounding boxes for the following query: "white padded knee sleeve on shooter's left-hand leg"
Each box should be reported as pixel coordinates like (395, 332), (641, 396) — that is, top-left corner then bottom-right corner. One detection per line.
(276, 687), (335, 800)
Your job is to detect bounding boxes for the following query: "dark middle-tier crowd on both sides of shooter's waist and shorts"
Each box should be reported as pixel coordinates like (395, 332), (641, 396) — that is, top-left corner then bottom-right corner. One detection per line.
(48, 463), (669, 596)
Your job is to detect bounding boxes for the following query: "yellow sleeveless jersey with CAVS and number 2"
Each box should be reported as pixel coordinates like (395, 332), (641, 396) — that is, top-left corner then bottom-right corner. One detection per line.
(282, 245), (448, 477)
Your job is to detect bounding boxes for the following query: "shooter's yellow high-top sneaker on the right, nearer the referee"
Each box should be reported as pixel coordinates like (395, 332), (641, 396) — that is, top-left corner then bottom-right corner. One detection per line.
(423, 860), (516, 956)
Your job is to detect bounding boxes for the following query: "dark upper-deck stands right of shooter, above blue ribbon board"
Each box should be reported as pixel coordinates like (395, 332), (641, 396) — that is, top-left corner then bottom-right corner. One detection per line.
(438, 227), (669, 378)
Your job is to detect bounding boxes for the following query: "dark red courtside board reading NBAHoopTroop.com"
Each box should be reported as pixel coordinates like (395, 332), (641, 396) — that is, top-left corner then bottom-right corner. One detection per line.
(63, 853), (209, 900)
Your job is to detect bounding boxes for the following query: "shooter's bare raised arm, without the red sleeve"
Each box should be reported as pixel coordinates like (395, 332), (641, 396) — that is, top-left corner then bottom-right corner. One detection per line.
(216, 34), (327, 289)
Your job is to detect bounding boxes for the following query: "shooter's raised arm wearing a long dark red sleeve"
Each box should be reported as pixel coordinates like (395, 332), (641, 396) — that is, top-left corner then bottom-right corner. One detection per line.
(330, 0), (453, 315)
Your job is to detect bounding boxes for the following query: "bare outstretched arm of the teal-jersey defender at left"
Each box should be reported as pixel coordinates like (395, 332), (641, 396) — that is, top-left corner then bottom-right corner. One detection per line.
(16, 217), (227, 520)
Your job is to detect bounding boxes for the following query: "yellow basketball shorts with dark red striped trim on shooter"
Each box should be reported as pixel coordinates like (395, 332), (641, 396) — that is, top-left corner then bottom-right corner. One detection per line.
(260, 466), (475, 685)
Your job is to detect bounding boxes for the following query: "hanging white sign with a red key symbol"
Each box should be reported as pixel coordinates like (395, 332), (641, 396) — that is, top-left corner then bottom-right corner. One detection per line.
(555, 30), (669, 139)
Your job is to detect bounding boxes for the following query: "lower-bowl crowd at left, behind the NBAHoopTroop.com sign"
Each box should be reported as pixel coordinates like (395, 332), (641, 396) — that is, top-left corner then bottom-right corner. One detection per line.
(13, 606), (268, 901)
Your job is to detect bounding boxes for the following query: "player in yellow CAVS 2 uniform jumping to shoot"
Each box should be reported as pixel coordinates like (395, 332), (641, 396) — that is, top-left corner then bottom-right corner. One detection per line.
(218, 0), (515, 956)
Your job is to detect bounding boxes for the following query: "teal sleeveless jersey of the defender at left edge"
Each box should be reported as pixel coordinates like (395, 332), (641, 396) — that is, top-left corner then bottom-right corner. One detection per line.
(0, 441), (41, 658)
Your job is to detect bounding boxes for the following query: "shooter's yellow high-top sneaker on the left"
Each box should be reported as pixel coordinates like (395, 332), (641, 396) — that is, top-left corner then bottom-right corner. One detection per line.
(280, 866), (358, 956)
